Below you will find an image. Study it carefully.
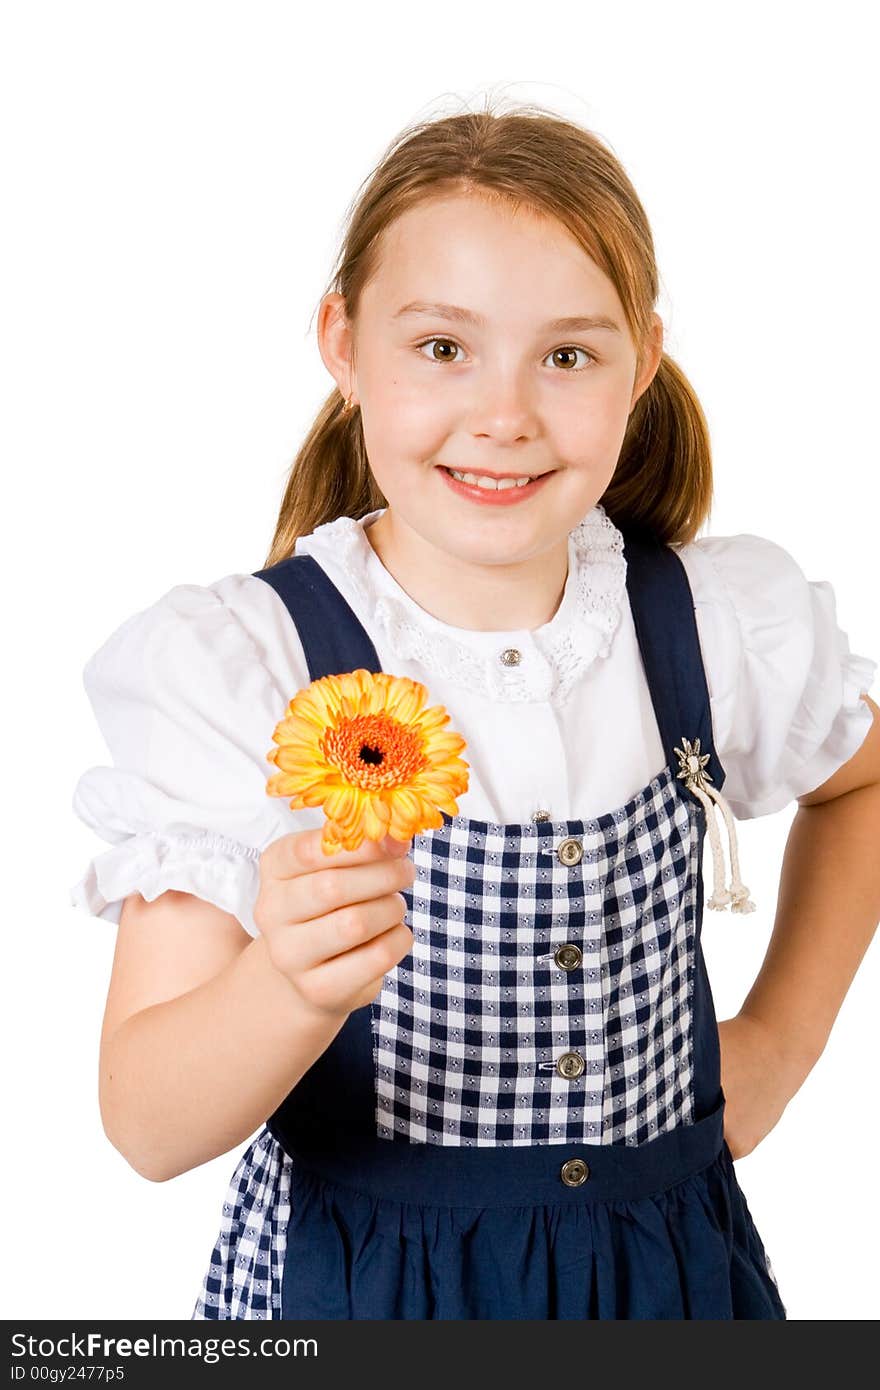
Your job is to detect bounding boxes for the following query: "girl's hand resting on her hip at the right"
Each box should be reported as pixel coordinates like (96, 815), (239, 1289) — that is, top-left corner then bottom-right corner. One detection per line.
(717, 1013), (805, 1158)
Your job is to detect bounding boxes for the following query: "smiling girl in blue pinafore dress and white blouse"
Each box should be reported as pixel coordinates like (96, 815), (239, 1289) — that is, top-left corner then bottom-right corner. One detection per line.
(74, 107), (880, 1319)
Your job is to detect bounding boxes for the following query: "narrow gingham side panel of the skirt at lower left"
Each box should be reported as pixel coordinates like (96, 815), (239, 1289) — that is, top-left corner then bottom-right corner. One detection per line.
(192, 1129), (292, 1319)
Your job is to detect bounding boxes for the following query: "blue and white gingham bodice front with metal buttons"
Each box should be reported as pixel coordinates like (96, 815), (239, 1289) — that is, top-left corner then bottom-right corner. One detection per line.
(371, 767), (699, 1145)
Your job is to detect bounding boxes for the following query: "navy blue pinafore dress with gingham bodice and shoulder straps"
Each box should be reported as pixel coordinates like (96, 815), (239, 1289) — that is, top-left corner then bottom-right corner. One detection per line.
(193, 530), (785, 1319)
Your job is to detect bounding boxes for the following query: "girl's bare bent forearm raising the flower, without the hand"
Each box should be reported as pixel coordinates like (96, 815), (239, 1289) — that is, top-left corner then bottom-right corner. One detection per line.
(99, 892), (345, 1182)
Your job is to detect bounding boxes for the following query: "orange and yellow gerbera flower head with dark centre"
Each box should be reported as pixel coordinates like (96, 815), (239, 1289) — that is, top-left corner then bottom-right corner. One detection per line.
(266, 669), (467, 855)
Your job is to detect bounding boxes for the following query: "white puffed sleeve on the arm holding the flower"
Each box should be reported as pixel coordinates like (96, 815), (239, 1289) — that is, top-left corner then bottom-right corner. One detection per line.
(71, 574), (309, 935)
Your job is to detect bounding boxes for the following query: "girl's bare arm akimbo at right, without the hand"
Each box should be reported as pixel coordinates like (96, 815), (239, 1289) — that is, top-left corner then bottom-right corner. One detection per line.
(722, 695), (880, 1117)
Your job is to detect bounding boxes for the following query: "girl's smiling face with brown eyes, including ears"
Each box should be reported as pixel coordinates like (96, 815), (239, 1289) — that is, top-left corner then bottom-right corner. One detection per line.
(320, 193), (662, 586)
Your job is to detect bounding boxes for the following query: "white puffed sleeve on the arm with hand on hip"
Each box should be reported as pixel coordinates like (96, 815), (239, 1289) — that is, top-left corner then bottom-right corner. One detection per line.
(676, 534), (877, 820)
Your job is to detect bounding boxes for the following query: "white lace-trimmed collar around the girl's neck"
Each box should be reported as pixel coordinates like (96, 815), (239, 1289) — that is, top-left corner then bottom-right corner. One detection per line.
(295, 503), (627, 702)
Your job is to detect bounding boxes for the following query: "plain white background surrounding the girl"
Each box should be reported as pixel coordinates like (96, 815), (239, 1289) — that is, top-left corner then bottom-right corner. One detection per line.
(0, 0), (880, 1319)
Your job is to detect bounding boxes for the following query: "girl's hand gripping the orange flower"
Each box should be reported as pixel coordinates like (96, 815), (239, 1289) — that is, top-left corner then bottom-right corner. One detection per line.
(253, 827), (416, 1022)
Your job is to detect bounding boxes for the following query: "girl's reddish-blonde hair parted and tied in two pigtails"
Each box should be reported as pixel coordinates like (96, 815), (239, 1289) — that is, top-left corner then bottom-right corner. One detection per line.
(266, 104), (712, 566)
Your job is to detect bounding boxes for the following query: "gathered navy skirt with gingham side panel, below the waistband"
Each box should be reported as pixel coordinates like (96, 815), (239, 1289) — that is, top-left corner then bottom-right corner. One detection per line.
(192, 1129), (787, 1319)
